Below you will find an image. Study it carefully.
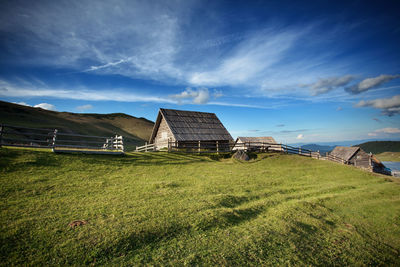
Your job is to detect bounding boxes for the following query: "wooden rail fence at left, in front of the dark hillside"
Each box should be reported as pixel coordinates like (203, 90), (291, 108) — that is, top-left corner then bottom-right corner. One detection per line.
(0, 124), (124, 153)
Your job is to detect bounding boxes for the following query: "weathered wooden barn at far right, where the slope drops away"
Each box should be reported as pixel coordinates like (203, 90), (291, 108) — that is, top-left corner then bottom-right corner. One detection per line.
(330, 146), (386, 173)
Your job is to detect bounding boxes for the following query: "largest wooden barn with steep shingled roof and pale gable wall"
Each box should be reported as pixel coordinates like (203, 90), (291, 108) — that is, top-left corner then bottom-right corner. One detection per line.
(149, 108), (233, 151)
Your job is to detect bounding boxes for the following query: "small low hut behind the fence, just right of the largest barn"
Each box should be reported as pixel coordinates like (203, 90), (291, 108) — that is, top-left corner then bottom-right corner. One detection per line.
(233, 136), (282, 151)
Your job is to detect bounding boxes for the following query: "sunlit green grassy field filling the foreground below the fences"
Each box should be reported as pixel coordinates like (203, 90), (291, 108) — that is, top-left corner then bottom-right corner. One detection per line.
(0, 148), (400, 266)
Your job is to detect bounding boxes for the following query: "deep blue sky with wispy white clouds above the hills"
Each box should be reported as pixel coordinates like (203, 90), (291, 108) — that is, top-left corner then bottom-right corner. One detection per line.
(0, 0), (400, 143)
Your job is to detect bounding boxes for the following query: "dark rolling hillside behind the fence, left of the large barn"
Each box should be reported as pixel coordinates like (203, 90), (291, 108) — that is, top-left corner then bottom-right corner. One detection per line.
(0, 101), (154, 150)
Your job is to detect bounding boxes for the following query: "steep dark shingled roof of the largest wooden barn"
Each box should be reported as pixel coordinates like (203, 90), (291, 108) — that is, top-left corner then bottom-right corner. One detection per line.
(150, 108), (233, 143)
